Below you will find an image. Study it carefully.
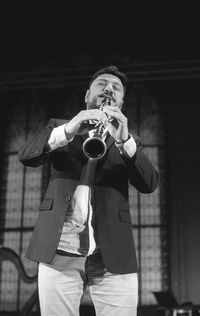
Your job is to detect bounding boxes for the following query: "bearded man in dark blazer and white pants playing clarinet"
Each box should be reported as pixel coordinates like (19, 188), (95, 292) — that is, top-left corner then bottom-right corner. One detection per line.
(19, 66), (158, 316)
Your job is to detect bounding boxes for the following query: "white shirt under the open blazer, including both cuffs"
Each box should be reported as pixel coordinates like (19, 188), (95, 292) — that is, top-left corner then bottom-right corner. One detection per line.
(48, 124), (136, 256)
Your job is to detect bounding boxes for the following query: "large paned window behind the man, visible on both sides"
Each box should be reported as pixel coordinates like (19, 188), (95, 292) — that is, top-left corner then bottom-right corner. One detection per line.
(0, 76), (168, 311)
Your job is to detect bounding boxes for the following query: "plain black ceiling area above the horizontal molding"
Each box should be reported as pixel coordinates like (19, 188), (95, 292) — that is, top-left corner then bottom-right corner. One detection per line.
(0, 0), (200, 73)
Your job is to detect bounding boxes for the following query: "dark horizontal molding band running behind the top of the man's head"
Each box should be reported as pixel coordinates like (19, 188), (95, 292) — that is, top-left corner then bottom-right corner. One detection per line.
(0, 60), (200, 91)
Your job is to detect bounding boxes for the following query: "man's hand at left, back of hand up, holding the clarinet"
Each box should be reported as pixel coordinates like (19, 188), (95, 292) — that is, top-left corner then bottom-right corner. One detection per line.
(65, 109), (106, 140)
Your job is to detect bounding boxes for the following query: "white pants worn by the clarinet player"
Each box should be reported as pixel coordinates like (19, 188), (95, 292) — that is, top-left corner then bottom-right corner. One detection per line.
(38, 254), (138, 316)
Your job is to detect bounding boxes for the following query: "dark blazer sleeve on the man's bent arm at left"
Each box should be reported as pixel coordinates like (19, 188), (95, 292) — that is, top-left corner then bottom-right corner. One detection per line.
(18, 119), (66, 167)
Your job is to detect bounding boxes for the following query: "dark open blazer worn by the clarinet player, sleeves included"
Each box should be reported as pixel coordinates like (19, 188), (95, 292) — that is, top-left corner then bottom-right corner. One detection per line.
(19, 119), (158, 273)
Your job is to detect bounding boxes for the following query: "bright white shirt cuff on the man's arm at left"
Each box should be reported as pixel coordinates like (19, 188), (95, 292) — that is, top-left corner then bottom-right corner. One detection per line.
(48, 124), (74, 150)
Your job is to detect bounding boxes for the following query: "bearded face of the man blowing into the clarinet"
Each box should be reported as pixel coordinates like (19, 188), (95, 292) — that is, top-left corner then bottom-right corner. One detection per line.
(85, 74), (124, 110)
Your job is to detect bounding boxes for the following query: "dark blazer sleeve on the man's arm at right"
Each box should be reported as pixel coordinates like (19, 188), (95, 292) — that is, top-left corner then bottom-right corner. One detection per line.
(124, 135), (159, 193)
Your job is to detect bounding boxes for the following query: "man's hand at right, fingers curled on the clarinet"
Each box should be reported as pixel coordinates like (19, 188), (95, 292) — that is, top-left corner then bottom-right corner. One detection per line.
(104, 106), (128, 143)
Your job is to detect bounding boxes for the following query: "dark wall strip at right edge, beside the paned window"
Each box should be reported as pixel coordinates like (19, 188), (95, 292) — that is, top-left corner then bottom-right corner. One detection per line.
(167, 82), (200, 304)
